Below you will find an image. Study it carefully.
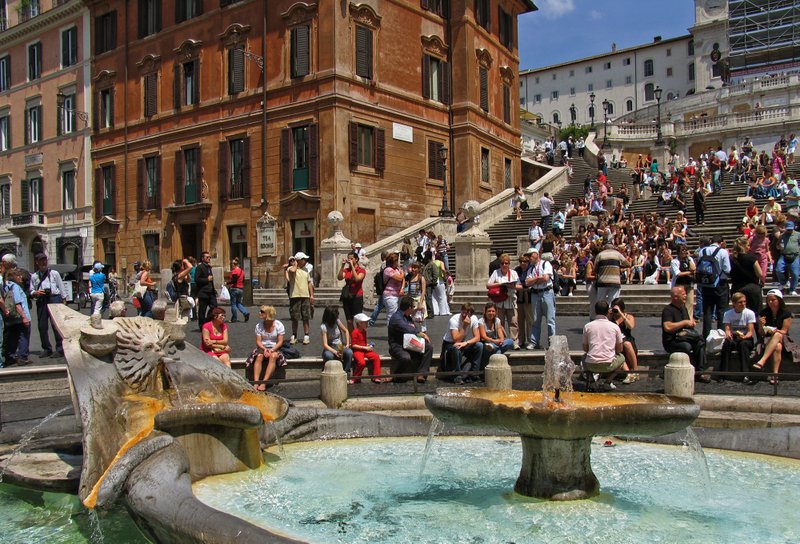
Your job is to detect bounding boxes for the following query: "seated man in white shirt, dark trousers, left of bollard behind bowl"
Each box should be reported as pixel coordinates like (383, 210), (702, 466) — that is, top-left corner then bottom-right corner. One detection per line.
(441, 302), (483, 385)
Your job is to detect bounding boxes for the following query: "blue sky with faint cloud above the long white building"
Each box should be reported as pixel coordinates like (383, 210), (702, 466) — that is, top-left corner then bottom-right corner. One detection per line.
(519, 0), (694, 70)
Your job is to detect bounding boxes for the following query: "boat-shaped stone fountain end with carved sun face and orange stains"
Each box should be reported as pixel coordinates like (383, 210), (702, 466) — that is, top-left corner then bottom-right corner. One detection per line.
(50, 301), (294, 542)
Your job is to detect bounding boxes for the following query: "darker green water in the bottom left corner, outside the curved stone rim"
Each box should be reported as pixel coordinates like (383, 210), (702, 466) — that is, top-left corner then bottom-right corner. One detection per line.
(0, 484), (148, 544)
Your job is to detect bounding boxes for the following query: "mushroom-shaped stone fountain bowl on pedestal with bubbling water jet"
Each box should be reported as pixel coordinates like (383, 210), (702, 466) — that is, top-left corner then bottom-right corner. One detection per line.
(425, 336), (700, 500)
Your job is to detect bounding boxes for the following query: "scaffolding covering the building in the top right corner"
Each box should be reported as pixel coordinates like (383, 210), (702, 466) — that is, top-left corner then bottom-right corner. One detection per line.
(728, 0), (800, 76)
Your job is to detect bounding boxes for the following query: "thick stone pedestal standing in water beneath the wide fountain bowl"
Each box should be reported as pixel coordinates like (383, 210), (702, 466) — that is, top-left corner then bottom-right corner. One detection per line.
(514, 436), (600, 501)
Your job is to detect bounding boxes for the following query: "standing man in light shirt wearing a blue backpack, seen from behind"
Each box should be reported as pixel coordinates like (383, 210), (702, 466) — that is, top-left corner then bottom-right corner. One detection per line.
(695, 234), (731, 339)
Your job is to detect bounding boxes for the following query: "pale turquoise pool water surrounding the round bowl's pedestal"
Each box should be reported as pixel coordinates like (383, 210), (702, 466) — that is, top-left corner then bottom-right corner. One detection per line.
(195, 438), (800, 544)
